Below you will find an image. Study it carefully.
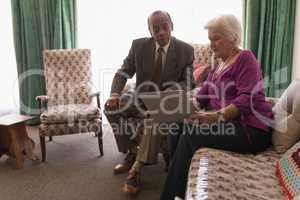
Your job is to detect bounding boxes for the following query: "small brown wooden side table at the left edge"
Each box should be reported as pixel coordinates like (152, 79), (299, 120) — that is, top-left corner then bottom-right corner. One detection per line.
(0, 114), (37, 169)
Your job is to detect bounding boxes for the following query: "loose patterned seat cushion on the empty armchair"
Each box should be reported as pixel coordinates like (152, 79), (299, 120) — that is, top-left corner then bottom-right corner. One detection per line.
(41, 104), (100, 124)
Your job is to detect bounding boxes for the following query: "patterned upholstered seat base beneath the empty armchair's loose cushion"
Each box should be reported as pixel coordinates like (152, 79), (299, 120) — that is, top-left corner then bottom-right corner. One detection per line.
(39, 119), (101, 136)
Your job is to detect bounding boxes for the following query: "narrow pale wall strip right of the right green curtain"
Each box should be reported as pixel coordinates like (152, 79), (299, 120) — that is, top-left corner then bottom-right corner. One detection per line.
(292, 0), (300, 79)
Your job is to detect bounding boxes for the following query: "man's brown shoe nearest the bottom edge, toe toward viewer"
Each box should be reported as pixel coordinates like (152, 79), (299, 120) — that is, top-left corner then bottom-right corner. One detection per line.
(122, 171), (141, 195)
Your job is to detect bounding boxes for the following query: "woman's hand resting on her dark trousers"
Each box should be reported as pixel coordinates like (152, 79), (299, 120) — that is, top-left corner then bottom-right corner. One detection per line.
(187, 111), (218, 124)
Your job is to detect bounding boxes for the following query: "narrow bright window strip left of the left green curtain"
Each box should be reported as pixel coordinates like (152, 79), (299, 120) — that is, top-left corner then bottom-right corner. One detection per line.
(0, 0), (19, 111)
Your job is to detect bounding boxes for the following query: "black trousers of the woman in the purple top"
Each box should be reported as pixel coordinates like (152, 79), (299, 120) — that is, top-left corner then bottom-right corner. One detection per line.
(160, 122), (271, 200)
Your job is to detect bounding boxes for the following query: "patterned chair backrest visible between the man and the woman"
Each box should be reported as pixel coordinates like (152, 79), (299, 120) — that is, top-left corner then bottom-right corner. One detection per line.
(191, 44), (220, 66)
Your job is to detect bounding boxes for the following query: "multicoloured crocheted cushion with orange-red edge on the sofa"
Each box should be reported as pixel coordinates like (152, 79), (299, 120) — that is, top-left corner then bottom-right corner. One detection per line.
(276, 142), (300, 199)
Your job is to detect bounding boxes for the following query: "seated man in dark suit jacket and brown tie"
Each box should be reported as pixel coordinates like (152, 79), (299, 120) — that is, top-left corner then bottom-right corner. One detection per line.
(105, 11), (194, 194)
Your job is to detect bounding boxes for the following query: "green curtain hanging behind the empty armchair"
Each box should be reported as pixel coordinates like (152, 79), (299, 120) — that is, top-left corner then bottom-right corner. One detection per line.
(11, 0), (77, 115)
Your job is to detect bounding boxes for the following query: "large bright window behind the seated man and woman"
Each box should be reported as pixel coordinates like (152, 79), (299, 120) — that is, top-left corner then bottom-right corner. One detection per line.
(77, 0), (242, 102)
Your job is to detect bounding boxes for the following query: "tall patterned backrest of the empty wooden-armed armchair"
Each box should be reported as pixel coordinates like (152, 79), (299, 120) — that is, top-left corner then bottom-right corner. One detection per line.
(43, 49), (92, 106)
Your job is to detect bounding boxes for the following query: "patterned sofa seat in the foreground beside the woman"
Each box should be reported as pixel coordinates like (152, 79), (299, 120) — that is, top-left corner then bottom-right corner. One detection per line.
(186, 148), (284, 200)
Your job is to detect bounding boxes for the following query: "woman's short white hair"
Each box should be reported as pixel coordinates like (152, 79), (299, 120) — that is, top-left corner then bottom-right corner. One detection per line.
(204, 14), (242, 47)
